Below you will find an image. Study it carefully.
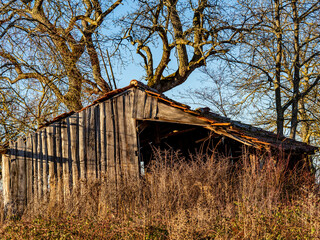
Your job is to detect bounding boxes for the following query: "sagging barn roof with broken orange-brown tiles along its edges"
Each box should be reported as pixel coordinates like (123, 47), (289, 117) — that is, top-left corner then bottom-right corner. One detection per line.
(35, 80), (318, 153)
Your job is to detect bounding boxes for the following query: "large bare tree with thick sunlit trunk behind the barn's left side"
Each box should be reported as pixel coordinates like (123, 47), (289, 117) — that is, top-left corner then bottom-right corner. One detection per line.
(0, 0), (122, 110)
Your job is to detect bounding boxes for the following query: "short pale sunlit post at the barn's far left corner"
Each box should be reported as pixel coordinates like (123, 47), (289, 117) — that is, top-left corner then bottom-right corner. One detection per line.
(2, 154), (12, 218)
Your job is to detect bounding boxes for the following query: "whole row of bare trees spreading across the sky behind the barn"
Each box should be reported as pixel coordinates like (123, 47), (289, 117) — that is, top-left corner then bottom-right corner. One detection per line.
(0, 0), (320, 142)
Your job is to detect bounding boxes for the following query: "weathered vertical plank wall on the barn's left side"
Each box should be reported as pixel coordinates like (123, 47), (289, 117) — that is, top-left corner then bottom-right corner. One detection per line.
(2, 89), (158, 214)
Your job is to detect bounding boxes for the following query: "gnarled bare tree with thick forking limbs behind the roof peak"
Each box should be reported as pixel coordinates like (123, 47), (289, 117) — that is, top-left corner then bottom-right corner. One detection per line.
(121, 0), (260, 92)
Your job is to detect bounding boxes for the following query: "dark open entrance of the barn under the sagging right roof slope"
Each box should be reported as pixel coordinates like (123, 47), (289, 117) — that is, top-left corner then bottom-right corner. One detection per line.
(137, 120), (243, 171)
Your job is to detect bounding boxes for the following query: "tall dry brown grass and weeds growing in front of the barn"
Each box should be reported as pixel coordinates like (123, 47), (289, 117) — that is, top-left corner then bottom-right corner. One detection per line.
(0, 152), (320, 239)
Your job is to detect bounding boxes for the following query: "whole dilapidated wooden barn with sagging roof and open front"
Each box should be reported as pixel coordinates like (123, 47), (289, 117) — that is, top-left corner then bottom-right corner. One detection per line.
(2, 80), (317, 215)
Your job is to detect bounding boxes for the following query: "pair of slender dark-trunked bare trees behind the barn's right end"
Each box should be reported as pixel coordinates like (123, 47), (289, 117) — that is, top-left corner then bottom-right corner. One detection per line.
(224, 0), (320, 141)
